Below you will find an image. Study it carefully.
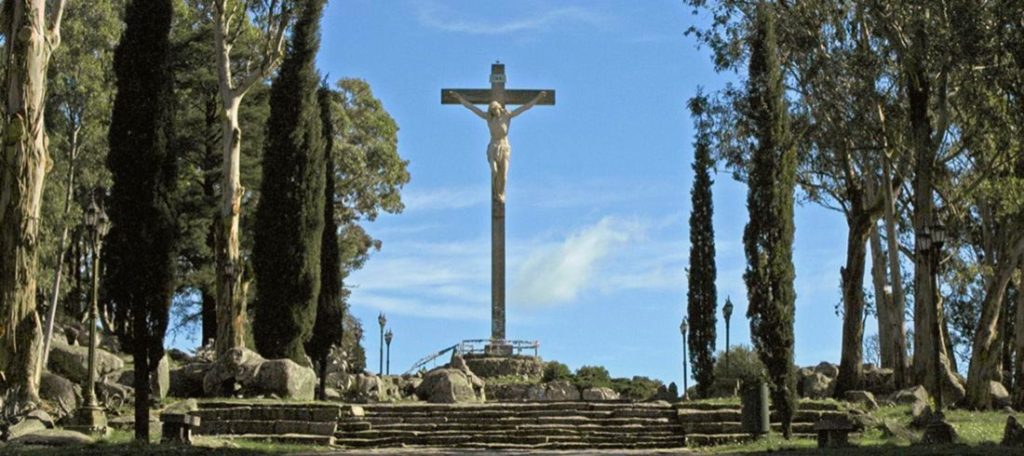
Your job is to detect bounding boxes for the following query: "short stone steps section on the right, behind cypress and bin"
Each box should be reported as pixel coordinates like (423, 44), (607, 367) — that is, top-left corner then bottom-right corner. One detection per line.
(676, 402), (849, 447)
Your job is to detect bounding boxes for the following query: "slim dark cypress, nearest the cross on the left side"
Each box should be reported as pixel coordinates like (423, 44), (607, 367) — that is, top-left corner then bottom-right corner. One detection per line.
(306, 84), (345, 400)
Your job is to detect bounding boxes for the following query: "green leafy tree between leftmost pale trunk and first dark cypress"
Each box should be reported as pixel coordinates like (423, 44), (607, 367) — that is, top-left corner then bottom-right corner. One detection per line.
(40, 0), (124, 366)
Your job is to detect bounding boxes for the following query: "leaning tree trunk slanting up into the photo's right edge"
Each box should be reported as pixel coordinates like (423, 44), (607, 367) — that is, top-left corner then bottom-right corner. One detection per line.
(965, 237), (1024, 409)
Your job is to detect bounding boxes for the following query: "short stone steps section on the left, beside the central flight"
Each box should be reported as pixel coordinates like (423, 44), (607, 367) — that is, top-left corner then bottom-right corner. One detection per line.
(190, 401), (341, 445)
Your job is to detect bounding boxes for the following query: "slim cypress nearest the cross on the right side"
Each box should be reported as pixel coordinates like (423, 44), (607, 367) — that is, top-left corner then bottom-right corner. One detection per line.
(686, 93), (718, 398)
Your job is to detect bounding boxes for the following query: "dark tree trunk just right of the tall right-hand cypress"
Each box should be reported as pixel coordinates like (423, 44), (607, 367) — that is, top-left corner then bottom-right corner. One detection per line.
(835, 211), (871, 398)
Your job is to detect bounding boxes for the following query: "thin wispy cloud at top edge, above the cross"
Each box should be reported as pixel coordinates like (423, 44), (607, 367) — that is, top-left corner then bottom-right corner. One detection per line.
(419, 2), (602, 35)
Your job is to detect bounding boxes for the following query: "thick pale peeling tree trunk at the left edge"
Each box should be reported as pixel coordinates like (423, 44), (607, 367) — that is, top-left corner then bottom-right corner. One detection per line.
(0, 0), (63, 406)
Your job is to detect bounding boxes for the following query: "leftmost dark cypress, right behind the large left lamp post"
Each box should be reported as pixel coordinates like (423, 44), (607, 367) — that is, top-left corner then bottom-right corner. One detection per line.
(104, 0), (177, 441)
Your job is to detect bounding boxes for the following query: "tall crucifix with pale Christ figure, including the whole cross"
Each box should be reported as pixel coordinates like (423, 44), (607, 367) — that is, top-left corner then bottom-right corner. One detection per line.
(441, 63), (555, 355)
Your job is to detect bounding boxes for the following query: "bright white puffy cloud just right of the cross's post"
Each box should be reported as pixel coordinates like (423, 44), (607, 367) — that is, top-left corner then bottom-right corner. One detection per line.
(512, 217), (641, 306)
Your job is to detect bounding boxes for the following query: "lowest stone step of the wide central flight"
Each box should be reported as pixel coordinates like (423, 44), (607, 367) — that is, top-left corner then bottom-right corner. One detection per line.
(335, 433), (683, 448)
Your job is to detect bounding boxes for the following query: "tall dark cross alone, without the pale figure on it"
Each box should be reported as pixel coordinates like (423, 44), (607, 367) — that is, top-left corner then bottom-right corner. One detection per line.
(441, 63), (555, 355)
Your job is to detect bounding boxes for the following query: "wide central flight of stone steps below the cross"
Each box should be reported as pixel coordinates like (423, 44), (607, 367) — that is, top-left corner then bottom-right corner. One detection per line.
(335, 402), (684, 450)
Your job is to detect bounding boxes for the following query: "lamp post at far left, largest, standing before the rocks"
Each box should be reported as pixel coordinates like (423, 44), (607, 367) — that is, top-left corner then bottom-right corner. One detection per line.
(77, 200), (111, 433)
